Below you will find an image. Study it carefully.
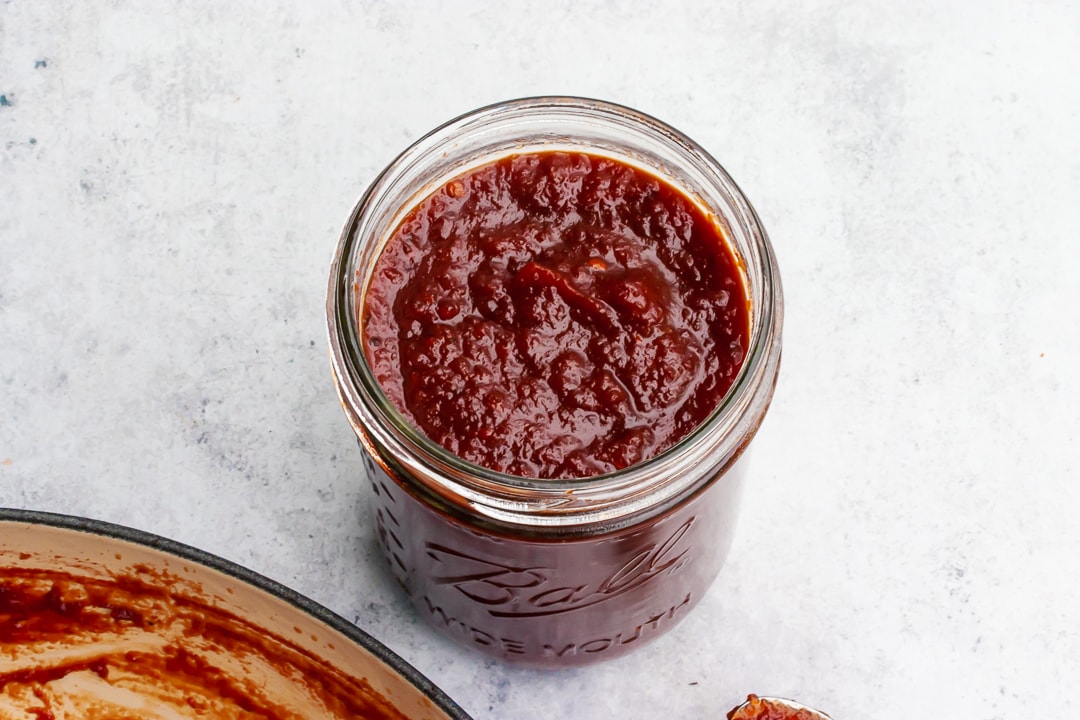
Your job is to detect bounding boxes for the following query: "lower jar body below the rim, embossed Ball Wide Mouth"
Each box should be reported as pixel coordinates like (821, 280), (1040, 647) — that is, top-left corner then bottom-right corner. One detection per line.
(365, 446), (743, 668)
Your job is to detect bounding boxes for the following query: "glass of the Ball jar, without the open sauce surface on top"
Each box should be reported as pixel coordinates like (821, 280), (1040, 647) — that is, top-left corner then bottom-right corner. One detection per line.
(326, 97), (783, 667)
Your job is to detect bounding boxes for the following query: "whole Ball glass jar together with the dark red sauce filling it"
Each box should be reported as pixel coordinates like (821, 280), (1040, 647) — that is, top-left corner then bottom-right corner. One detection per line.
(327, 98), (783, 667)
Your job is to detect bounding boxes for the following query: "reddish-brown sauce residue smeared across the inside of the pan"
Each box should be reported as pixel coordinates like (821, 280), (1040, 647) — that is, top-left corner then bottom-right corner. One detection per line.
(0, 568), (404, 720)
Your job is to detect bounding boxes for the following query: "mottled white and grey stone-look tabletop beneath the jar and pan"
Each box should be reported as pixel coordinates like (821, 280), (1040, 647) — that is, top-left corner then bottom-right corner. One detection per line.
(0, 0), (1080, 720)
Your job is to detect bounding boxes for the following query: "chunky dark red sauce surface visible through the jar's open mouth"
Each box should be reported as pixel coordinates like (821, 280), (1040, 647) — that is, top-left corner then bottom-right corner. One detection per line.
(362, 152), (750, 477)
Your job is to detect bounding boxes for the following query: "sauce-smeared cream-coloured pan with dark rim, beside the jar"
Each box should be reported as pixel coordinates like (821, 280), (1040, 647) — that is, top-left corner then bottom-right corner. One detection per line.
(0, 508), (469, 720)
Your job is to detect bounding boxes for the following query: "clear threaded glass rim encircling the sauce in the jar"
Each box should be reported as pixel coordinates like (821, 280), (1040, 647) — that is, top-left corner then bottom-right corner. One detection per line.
(326, 96), (783, 528)
